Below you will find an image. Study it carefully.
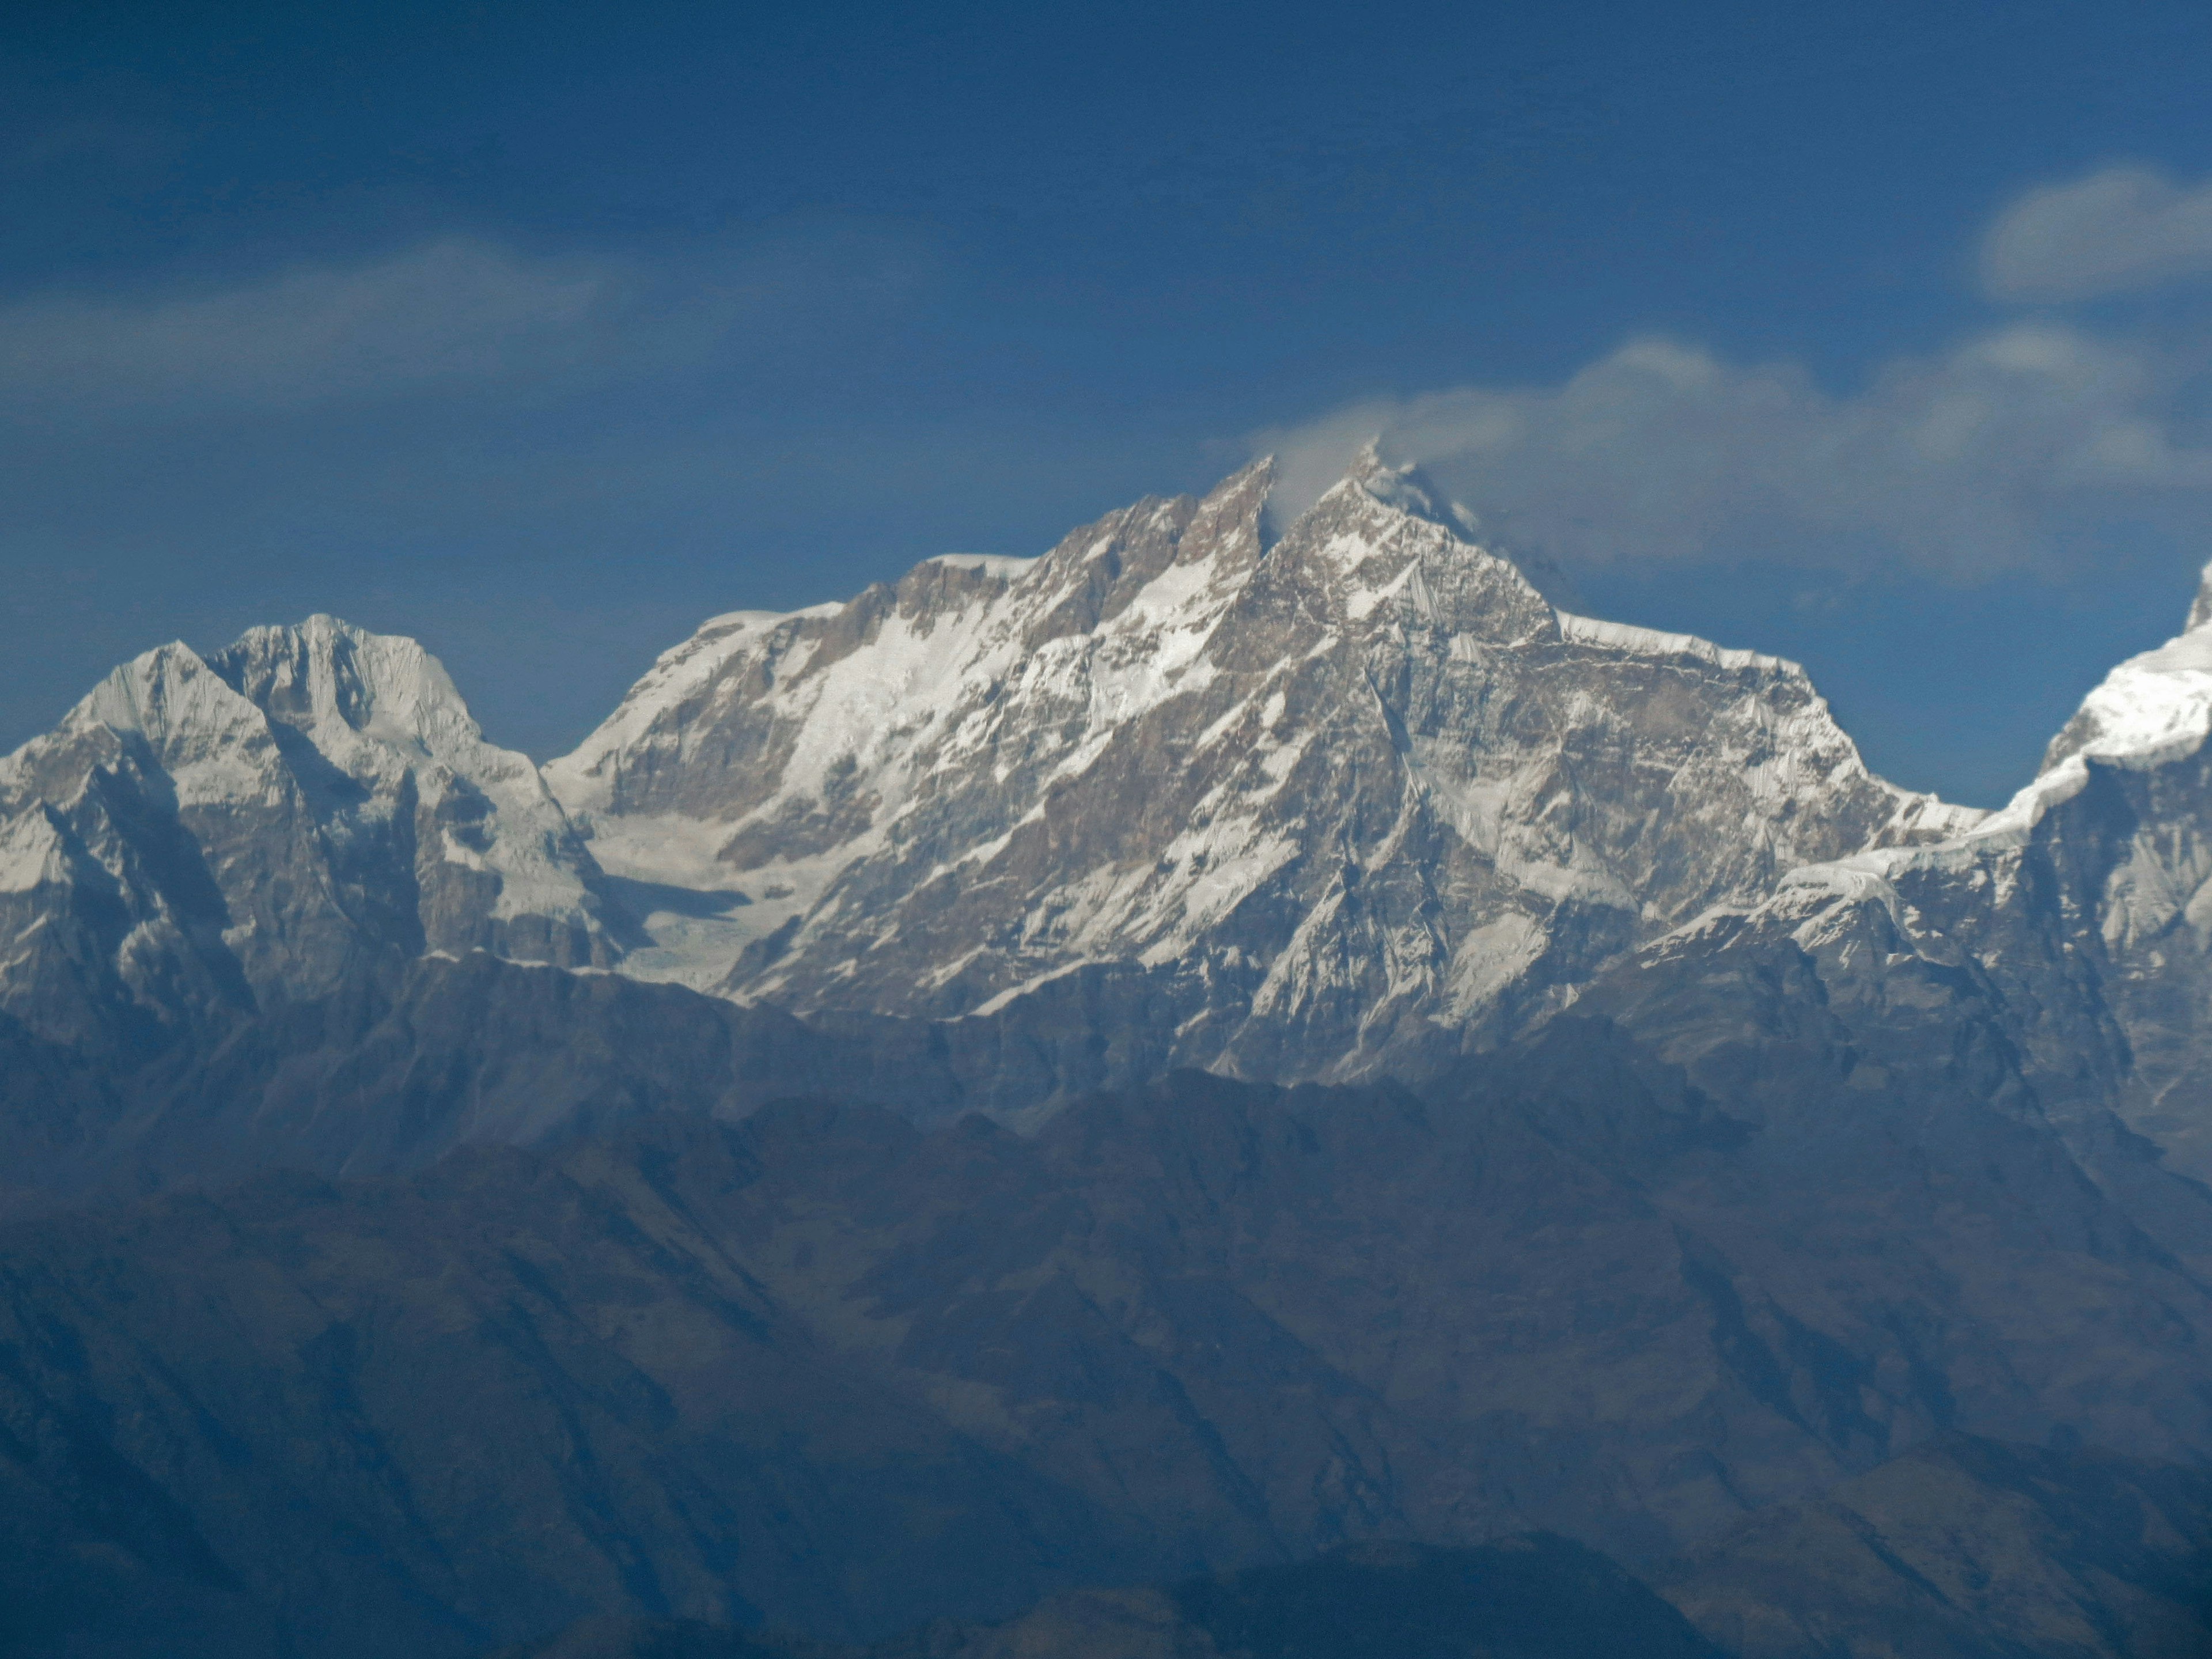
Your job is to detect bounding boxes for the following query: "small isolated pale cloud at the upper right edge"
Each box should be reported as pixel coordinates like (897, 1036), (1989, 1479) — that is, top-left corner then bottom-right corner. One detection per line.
(1982, 166), (2212, 301)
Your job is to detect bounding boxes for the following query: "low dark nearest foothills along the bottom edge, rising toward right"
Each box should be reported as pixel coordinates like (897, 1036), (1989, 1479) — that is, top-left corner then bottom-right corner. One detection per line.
(495, 1460), (2212, 1659)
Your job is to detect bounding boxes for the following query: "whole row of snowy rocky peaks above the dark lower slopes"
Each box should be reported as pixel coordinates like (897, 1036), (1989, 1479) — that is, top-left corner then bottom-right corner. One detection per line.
(13, 451), (2212, 1194)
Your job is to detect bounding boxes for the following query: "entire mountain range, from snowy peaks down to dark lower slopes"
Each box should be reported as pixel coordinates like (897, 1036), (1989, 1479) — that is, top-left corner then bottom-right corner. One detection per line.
(0, 451), (2212, 1659)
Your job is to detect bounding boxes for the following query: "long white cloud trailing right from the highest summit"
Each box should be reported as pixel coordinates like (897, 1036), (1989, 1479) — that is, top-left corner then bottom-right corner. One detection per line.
(1254, 323), (2212, 579)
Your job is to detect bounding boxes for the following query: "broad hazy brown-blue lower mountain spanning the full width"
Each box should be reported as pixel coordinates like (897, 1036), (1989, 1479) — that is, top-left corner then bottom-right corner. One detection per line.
(0, 1070), (2212, 1654)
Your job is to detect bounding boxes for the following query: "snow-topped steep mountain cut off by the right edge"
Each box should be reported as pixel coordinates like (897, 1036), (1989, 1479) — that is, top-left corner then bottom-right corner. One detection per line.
(1643, 566), (2212, 1179)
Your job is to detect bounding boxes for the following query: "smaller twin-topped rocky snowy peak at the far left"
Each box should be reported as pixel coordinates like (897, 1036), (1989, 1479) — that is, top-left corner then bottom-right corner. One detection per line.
(0, 617), (619, 1040)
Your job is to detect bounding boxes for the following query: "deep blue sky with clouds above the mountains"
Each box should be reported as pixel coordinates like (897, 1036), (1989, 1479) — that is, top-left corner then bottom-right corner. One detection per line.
(0, 2), (2212, 803)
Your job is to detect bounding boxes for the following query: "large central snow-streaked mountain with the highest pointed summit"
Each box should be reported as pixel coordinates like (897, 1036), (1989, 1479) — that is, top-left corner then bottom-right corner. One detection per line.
(546, 453), (1975, 1077)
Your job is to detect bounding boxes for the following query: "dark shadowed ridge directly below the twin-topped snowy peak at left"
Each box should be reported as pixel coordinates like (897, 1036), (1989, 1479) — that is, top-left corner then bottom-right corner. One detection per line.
(0, 951), (1203, 1214)
